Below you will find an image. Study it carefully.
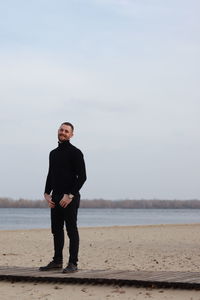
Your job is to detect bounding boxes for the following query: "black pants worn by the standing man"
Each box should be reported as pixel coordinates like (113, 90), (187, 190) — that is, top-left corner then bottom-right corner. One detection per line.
(51, 194), (80, 265)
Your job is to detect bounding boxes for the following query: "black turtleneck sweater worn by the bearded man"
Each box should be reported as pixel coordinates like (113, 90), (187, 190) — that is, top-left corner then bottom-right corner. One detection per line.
(45, 141), (86, 195)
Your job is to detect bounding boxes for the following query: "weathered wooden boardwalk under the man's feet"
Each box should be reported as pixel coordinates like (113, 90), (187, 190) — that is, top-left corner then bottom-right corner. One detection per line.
(0, 266), (200, 290)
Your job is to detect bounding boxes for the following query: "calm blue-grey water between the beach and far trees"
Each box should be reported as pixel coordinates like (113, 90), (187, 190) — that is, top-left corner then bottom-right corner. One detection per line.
(0, 208), (200, 230)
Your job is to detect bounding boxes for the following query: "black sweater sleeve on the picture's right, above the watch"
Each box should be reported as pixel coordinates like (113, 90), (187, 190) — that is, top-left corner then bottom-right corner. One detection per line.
(70, 150), (87, 195)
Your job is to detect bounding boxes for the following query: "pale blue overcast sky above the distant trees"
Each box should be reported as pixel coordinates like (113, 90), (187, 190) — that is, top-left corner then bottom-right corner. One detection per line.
(0, 0), (200, 199)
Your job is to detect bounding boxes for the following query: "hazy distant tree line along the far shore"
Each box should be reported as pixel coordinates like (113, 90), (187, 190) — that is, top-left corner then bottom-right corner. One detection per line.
(0, 198), (200, 209)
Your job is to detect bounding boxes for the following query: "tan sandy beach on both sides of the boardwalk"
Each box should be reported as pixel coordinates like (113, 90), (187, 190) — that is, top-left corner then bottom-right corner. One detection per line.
(0, 224), (200, 300)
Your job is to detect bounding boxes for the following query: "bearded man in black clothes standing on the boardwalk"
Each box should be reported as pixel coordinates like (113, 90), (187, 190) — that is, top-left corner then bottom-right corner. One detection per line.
(39, 122), (86, 273)
